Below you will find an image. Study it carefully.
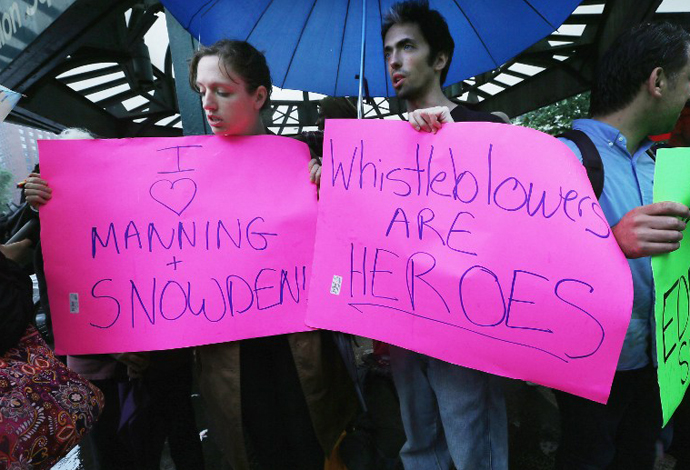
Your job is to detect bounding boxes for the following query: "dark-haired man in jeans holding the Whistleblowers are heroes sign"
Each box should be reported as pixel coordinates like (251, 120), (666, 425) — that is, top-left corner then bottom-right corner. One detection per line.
(381, 1), (508, 470)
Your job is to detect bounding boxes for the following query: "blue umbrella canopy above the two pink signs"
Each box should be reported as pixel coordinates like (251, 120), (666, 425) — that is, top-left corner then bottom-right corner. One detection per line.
(162, 0), (581, 96)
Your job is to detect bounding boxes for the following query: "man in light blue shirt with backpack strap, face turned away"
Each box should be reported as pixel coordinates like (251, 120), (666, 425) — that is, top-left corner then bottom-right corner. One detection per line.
(556, 23), (690, 470)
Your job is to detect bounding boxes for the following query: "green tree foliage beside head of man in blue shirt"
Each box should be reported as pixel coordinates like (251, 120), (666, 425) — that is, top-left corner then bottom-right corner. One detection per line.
(515, 92), (589, 135)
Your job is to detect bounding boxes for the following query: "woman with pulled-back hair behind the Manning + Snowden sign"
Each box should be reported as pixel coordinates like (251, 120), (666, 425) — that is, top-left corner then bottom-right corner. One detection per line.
(190, 40), (356, 470)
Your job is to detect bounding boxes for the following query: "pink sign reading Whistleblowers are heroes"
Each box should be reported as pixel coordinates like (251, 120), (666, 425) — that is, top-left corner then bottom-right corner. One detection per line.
(307, 121), (632, 402)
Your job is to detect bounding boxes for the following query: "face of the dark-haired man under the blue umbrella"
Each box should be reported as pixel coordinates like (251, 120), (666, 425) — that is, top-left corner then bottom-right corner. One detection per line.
(383, 23), (445, 100)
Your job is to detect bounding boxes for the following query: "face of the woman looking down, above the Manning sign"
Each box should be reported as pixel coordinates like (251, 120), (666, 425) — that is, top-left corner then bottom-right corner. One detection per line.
(196, 55), (266, 135)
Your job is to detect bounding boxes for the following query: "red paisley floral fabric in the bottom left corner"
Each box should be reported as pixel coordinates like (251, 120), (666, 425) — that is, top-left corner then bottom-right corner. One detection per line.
(0, 326), (104, 470)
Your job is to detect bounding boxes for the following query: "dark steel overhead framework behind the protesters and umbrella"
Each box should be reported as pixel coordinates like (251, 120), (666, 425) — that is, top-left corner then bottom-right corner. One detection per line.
(0, 0), (690, 137)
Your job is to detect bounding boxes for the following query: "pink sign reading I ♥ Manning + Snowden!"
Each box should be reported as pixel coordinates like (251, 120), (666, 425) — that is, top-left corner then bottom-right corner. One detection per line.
(39, 136), (316, 354)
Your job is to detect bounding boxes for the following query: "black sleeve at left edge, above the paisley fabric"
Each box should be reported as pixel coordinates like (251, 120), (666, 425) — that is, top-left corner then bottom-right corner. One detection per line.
(0, 253), (34, 355)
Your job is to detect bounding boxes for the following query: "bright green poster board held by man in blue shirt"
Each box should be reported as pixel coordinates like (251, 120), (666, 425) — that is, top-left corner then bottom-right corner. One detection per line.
(652, 148), (690, 426)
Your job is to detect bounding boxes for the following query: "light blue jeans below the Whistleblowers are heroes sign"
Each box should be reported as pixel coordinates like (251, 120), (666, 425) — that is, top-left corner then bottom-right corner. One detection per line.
(390, 346), (508, 470)
